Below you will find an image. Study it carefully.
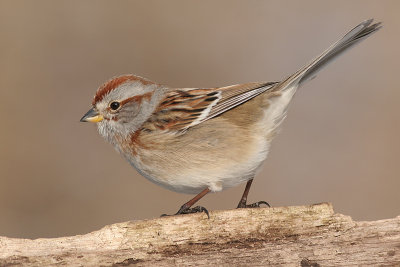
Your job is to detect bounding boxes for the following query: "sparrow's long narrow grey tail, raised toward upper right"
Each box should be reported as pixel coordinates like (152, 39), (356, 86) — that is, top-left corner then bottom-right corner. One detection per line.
(276, 19), (382, 90)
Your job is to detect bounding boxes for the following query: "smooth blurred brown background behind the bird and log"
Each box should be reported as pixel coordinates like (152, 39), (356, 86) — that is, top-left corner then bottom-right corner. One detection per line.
(0, 0), (400, 238)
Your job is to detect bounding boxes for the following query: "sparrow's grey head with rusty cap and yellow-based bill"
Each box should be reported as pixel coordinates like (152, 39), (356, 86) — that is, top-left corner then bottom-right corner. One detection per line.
(80, 75), (164, 143)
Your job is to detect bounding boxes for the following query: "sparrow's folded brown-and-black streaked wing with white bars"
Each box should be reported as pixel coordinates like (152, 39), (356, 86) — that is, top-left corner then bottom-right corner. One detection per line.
(147, 82), (276, 131)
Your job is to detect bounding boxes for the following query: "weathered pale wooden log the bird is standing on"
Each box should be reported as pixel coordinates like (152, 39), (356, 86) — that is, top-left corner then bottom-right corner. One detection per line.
(0, 203), (400, 266)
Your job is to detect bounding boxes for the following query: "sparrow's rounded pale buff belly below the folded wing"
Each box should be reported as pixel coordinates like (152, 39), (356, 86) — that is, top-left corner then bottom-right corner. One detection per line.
(122, 117), (269, 194)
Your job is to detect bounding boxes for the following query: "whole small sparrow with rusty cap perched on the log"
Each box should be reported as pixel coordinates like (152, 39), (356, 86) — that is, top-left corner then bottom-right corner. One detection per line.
(81, 19), (381, 219)
